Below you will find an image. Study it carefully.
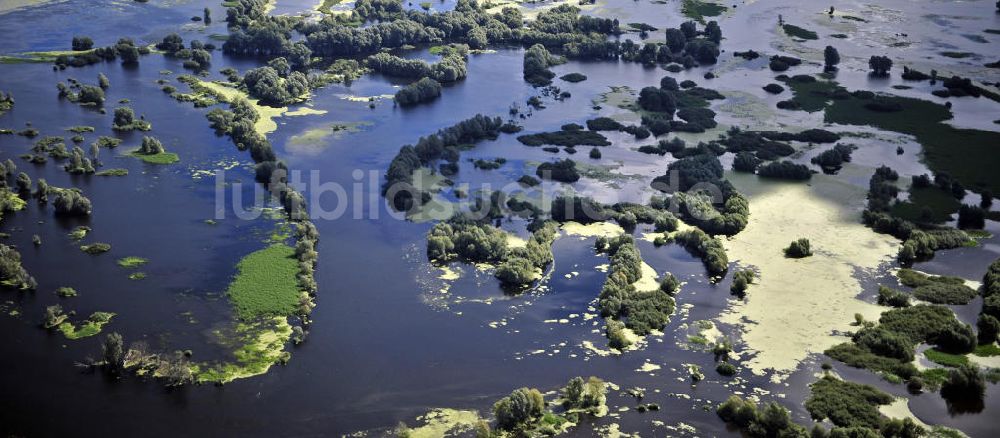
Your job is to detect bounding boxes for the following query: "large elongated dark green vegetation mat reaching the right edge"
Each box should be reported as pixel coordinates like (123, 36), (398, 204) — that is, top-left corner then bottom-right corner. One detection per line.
(824, 95), (1000, 193)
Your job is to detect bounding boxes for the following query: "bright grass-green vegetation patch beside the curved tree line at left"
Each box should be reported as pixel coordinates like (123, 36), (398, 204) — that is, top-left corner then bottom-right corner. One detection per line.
(226, 243), (301, 321)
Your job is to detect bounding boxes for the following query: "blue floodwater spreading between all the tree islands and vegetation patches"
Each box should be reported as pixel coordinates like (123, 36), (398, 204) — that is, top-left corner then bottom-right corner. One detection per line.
(0, 0), (1000, 437)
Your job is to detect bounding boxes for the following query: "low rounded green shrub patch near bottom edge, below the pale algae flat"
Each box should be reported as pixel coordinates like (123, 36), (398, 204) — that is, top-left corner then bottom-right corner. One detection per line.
(805, 375), (893, 429)
